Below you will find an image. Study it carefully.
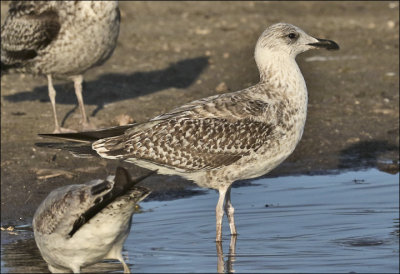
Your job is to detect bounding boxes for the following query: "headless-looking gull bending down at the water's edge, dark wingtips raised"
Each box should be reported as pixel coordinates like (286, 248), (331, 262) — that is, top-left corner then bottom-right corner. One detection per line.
(33, 167), (150, 273)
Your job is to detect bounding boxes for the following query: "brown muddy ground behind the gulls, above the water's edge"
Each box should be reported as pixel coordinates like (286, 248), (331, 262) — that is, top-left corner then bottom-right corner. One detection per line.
(1, 1), (399, 225)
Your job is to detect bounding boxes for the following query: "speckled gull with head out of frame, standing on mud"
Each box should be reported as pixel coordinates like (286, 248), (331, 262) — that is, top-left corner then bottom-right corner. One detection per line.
(1, 1), (120, 132)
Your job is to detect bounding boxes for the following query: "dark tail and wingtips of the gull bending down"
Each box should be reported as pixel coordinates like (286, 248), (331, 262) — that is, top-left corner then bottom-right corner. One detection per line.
(68, 167), (157, 237)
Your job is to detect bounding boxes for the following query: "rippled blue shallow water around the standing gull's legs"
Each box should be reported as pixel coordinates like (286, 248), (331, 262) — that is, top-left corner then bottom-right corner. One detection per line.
(1, 169), (399, 273)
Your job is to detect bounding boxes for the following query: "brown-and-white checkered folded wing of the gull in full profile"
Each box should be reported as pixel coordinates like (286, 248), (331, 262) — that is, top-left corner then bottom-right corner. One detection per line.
(92, 88), (276, 172)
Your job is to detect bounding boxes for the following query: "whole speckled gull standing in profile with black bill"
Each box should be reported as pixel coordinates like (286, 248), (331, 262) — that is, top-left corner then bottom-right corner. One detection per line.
(37, 23), (339, 241)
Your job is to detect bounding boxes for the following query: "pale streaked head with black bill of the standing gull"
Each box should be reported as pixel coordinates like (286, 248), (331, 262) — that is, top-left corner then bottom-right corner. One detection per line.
(255, 23), (339, 63)
